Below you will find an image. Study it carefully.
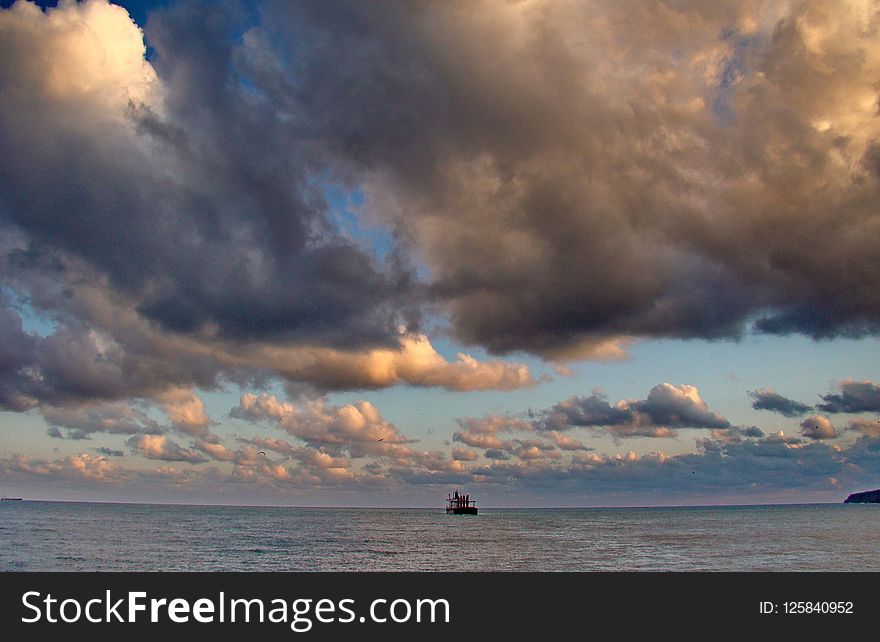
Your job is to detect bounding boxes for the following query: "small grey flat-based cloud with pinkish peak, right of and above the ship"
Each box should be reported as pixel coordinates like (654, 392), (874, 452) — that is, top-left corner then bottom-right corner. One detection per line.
(536, 383), (730, 437)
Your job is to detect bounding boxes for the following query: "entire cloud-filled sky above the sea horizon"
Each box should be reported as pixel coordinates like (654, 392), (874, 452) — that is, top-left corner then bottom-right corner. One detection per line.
(0, 0), (880, 507)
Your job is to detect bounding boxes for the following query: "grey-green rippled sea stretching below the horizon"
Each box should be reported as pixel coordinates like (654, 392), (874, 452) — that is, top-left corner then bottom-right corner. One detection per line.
(0, 501), (880, 571)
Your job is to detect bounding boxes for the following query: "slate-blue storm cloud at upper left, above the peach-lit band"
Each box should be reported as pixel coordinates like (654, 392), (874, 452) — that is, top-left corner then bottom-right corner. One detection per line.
(0, 3), (414, 346)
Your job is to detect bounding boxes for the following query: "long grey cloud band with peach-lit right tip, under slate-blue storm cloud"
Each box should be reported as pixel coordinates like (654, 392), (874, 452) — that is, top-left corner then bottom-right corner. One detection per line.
(0, 272), (536, 412)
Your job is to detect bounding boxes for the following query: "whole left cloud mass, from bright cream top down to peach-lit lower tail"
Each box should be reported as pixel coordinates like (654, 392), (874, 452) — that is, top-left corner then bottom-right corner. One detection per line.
(0, 0), (535, 424)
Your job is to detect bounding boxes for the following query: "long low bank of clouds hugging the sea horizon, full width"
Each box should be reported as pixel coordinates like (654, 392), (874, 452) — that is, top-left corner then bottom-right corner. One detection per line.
(10, 434), (880, 505)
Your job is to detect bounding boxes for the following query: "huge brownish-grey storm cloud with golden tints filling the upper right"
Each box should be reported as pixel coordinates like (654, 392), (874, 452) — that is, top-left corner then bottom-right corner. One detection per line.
(244, 1), (880, 356)
